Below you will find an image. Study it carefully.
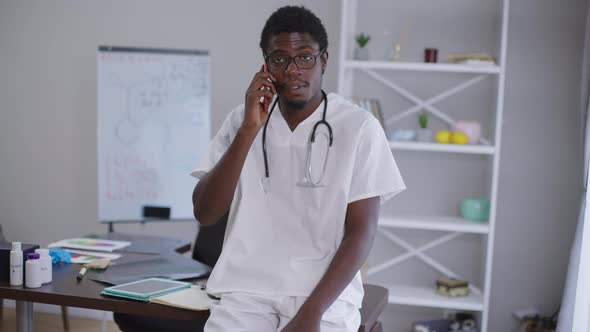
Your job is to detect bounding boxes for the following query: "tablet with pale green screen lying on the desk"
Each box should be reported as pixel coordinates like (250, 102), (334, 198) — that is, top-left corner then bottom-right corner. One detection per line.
(102, 278), (191, 301)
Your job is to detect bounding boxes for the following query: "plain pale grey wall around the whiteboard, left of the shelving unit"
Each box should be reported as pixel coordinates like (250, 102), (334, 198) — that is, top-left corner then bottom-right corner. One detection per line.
(0, 0), (339, 244)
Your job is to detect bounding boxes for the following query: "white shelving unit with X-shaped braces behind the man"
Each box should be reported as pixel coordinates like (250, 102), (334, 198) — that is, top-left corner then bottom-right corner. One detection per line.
(338, 0), (510, 332)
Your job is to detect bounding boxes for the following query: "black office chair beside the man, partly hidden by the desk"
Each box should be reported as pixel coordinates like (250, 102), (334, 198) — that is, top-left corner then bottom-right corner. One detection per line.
(113, 215), (227, 332)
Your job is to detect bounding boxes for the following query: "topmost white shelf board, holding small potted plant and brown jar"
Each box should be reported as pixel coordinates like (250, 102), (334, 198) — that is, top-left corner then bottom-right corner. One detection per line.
(345, 61), (500, 74)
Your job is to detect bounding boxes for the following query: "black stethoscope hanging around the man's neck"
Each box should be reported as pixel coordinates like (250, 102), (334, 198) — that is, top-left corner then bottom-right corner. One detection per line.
(262, 90), (334, 192)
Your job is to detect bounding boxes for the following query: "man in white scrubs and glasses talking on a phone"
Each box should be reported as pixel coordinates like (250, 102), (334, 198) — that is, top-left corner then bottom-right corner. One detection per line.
(192, 6), (405, 332)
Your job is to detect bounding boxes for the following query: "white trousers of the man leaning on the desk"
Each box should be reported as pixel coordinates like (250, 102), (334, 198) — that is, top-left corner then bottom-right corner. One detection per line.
(204, 293), (361, 332)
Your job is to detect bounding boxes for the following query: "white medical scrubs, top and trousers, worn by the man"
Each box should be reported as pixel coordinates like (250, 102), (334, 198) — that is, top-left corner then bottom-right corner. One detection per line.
(192, 93), (405, 331)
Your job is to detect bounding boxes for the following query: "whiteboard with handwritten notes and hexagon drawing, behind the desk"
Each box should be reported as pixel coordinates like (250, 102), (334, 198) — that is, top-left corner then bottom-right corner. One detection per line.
(97, 46), (211, 221)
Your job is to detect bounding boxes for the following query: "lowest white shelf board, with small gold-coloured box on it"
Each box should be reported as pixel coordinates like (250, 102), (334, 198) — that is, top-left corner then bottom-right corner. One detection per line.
(385, 285), (483, 311)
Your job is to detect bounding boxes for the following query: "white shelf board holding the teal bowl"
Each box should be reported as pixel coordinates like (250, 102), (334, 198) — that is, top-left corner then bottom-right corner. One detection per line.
(379, 216), (490, 234)
